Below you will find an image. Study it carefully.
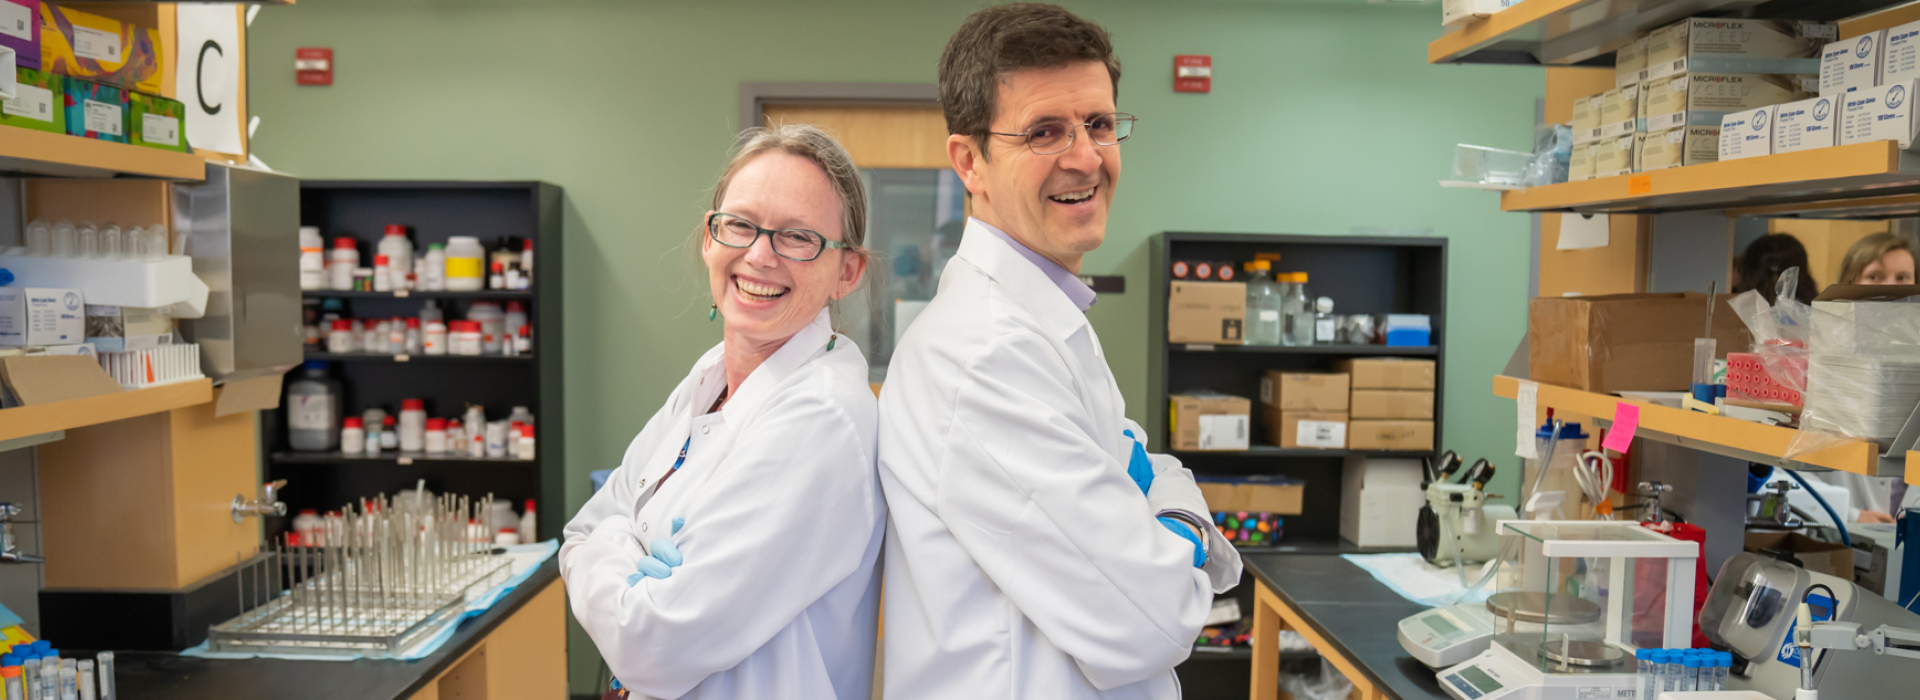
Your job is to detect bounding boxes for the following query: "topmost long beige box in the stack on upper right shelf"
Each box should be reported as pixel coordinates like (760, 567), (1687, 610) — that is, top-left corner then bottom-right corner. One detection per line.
(1647, 17), (1839, 81)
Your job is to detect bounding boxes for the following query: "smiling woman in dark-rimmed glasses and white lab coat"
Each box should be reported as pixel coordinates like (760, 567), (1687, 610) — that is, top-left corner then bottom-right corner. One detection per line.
(561, 125), (885, 700)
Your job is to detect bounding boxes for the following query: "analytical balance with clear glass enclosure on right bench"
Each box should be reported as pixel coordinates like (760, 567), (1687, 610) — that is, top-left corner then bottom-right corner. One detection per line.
(1438, 520), (1699, 700)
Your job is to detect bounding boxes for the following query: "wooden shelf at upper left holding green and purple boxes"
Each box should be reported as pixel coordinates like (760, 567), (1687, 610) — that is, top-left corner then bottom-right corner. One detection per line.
(0, 127), (207, 180)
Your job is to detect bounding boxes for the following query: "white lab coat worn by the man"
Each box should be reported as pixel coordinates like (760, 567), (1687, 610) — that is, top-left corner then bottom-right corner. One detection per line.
(879, 222), (1240, 700)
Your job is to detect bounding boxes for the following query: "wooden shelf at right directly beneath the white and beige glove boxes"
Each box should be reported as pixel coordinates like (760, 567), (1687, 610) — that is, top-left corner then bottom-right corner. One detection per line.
(1500, 140), (1920, 219)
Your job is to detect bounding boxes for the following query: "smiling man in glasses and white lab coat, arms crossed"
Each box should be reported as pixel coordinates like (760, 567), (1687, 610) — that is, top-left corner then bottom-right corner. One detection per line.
(879, 4), (1240, 700)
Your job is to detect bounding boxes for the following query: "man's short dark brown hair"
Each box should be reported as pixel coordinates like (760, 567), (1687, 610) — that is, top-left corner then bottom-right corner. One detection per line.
(941, 2), (1119, 158)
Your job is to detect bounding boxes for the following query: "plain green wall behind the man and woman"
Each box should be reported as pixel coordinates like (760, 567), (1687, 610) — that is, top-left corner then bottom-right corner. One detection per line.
(250, 0), (1542, 692)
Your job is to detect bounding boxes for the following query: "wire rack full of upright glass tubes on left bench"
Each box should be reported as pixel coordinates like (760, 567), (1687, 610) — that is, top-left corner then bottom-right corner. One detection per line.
(207, 491), (511, 658)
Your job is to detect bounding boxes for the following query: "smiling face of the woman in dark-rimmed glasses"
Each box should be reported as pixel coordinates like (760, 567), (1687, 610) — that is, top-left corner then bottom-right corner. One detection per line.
(701, 152), (866, 345)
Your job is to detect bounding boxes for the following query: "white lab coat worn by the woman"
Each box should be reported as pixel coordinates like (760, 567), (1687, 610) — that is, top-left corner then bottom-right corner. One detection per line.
(561, 311), (885, 700)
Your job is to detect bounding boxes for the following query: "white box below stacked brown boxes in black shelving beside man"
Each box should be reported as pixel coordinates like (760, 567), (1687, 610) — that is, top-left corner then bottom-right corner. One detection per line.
(1340, 455), (1427, 547)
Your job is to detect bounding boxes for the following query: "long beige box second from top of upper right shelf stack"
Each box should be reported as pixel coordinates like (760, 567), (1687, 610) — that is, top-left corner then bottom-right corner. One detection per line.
(1644, 73), (1820, 132)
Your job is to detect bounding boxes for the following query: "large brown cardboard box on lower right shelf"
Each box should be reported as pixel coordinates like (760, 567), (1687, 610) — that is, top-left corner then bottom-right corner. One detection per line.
(1526, 292), (1753, 393)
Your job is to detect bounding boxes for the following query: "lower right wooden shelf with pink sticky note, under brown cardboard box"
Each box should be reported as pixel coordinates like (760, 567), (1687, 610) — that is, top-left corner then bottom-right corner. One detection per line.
(1494, 376), (1881, 476)
